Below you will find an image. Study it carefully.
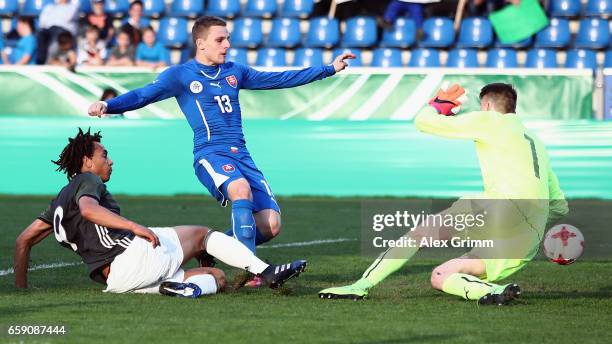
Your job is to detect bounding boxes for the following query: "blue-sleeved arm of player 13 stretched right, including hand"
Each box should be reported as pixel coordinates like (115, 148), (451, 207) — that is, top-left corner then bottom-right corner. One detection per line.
(238, 54), (355, 90)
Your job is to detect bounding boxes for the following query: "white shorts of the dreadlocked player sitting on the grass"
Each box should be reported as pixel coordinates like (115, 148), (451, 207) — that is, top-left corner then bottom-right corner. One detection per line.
(104, 227), (185, 293)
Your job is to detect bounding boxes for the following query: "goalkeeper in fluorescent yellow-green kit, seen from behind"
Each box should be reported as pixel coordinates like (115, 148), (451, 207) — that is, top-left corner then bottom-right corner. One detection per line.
(319, 83), (568, 305)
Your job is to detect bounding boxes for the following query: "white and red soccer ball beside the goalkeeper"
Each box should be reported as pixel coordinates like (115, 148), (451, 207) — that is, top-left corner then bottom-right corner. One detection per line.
(544, 224), (584, 265)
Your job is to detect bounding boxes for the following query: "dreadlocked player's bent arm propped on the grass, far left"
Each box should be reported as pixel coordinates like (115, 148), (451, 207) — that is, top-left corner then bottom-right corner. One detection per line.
(14, 219), (51, 288)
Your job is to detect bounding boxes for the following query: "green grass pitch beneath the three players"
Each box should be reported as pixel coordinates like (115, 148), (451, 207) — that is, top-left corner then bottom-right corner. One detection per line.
(0, 196), (612, 343)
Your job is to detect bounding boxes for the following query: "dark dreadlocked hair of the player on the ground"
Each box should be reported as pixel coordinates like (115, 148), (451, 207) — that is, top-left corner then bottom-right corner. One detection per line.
(51, 128), (102, 180)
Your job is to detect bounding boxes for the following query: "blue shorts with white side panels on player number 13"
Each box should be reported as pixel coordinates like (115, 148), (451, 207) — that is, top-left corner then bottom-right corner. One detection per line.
(193, 153), (280, 213)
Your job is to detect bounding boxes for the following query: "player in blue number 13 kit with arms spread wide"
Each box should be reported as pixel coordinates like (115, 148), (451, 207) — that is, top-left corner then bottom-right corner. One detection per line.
(89, 16), (355, 284)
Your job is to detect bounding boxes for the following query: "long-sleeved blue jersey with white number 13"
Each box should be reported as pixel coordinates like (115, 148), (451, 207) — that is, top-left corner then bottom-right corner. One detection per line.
(107, 59), (335, 160)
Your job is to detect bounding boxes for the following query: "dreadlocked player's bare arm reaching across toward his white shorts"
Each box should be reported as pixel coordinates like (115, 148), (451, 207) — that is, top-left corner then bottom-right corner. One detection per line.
(79, 197), (159, 247)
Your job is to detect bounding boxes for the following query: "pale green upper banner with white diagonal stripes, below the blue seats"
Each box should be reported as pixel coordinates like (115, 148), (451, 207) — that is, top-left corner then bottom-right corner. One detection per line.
(0, 67), (593, 120)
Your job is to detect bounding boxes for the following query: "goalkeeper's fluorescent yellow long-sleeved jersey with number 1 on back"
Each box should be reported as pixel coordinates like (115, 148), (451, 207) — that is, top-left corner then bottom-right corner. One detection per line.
(414, 106), (567, 210)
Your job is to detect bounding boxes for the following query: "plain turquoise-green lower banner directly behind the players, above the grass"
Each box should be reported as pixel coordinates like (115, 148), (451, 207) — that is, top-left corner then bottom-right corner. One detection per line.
(0, 117), (612, 199)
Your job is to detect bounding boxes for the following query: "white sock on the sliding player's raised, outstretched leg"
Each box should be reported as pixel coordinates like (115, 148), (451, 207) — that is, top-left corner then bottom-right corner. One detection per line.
(205, 231), (269, 274)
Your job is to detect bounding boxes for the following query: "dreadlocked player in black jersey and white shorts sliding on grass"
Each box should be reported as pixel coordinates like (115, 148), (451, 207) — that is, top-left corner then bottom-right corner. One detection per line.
(15, 129), (306, 297)
